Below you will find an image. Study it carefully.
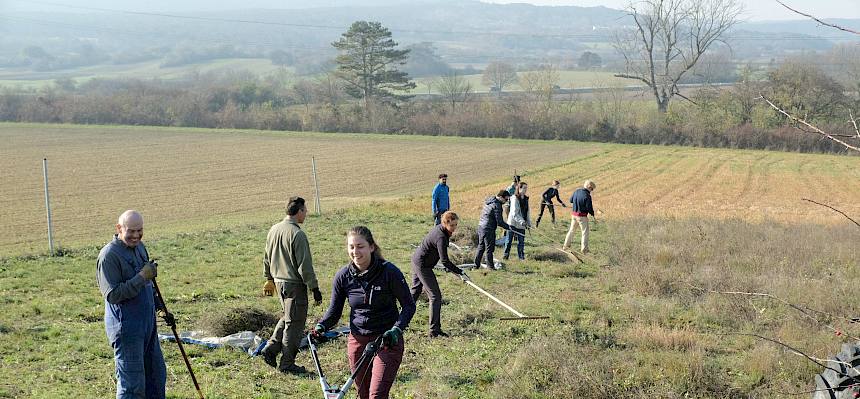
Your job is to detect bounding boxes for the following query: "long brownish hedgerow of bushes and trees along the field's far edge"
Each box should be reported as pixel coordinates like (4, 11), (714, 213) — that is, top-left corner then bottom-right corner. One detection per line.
(0, 52), (860, 151)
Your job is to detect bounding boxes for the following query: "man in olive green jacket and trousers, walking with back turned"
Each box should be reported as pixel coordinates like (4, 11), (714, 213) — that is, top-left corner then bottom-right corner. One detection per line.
(262, 197), (322, 374)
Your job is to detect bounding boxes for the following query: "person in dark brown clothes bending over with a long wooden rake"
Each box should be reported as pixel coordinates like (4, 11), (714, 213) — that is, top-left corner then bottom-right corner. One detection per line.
(411, 211), (468, 338)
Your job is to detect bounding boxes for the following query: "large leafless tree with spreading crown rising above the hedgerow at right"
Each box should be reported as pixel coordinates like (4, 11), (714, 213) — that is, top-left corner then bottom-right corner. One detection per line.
(615, 0), (743, 112)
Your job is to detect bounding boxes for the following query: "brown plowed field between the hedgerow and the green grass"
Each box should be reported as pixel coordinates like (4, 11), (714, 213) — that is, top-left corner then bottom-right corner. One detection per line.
(0, 124), (860, 255)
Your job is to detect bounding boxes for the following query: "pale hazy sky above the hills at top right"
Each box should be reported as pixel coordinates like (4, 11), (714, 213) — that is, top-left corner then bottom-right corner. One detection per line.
(482, 0), (860, 21)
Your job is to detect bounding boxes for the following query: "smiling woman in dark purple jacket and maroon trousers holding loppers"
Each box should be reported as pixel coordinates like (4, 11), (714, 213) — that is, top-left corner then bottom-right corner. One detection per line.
(314, 226), (415, 399)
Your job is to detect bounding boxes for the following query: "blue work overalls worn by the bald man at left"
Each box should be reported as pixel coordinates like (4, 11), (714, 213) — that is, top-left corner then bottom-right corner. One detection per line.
(97, 238), (167, 399)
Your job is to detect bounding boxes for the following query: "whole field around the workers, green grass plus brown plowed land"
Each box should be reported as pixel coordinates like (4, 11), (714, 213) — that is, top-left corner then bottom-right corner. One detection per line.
(0, 124), (860, 398)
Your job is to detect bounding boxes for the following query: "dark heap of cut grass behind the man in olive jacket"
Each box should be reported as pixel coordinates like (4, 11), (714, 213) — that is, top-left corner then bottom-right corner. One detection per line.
(197, 308), (280, 337)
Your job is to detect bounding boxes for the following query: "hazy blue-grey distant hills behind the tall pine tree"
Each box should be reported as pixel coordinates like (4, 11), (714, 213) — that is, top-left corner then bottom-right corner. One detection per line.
(0, 0), (860, 79)
